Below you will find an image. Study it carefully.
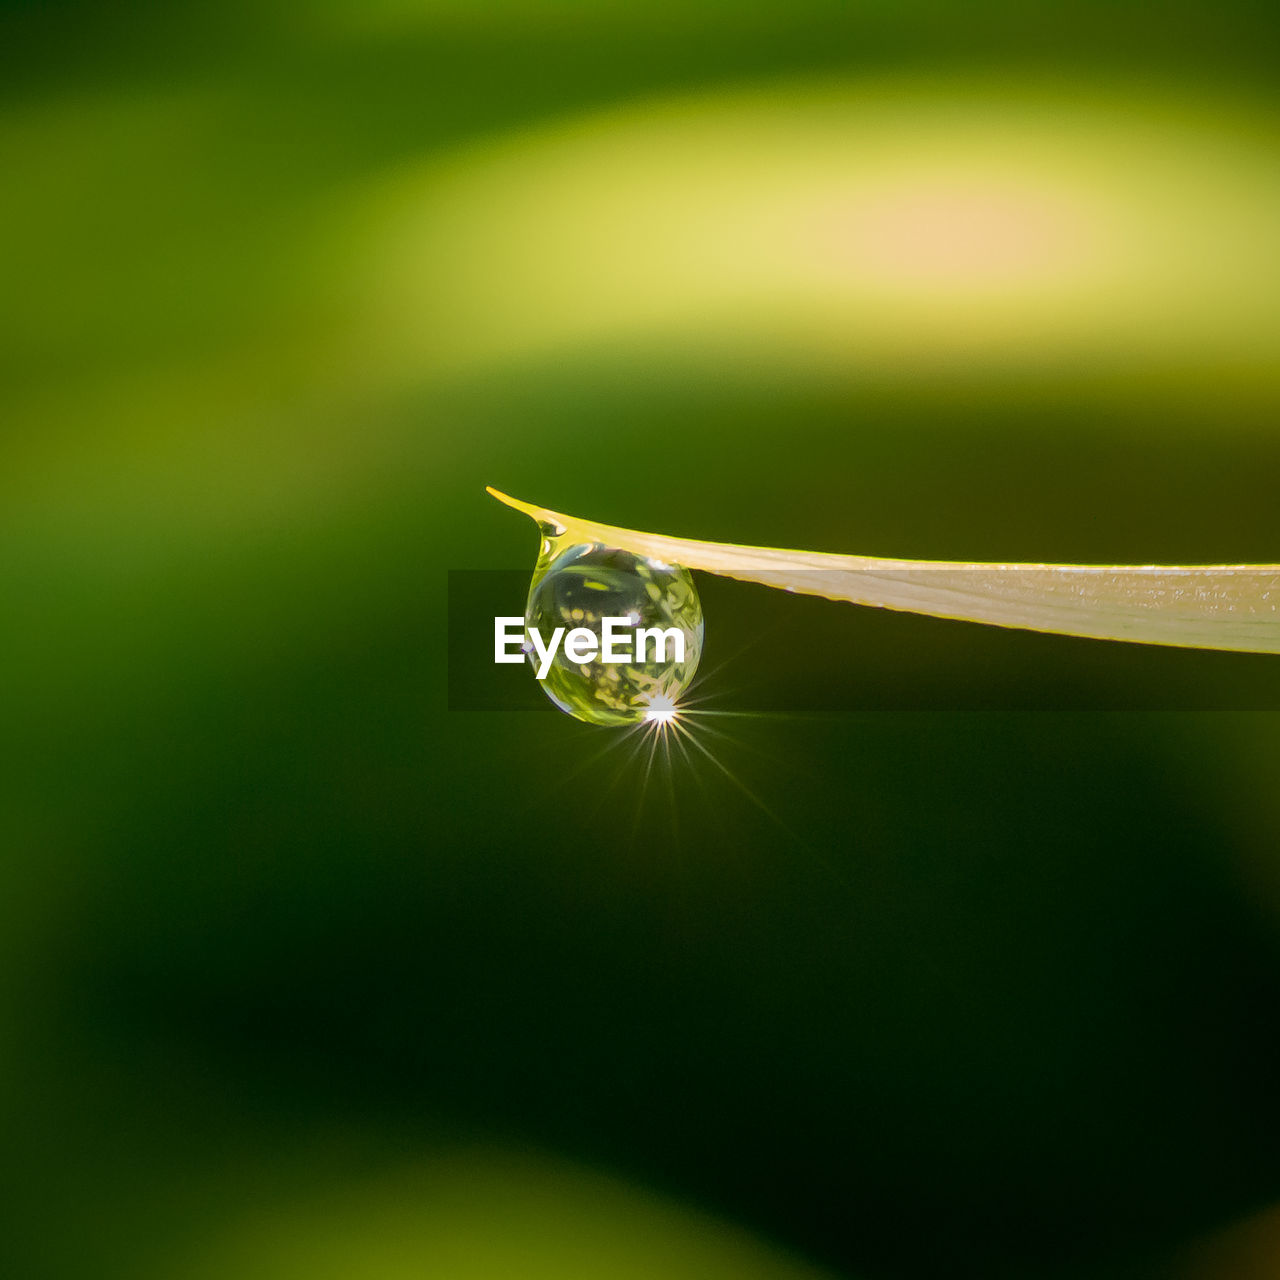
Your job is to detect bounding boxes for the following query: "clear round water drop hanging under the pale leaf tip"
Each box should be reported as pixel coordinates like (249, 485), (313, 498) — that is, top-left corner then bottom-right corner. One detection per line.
(525, 529), (703, 724)
